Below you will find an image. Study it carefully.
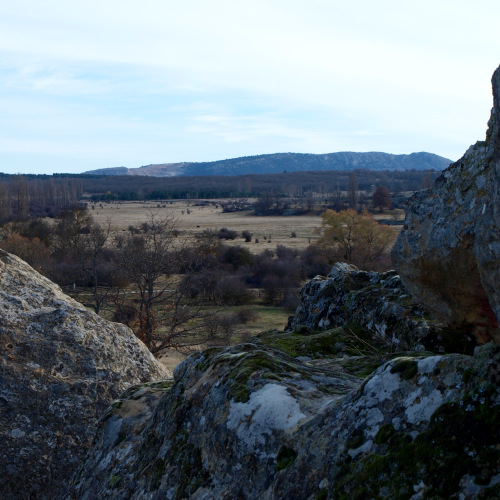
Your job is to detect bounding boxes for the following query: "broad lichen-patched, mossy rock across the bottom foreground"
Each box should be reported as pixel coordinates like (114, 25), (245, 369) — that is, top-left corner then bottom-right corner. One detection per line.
(67, 334), (500, 500)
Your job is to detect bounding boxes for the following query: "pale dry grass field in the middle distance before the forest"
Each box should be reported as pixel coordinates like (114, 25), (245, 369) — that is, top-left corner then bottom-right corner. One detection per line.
(90, 200), (321, 253)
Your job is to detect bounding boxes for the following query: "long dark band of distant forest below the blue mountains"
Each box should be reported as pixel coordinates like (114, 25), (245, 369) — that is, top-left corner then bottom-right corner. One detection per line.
(0, 170), (441, 221)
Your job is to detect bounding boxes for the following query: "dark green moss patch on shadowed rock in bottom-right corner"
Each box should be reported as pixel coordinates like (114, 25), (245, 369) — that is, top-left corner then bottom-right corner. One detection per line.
(333, 382), (500, 499)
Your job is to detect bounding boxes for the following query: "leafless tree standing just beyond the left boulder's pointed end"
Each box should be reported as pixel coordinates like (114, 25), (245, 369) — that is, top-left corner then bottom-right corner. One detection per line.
(120, 211), (209, 353)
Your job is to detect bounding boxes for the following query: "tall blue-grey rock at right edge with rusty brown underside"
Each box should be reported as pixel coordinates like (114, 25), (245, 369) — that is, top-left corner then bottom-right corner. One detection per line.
(392, 69), (500, 342)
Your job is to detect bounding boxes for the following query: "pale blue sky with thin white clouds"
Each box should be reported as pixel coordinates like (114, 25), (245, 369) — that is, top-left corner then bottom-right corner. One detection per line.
(0, 0), (500, 174)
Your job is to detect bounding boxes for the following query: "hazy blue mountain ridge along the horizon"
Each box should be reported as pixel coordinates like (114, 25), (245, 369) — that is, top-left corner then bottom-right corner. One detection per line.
(84, 151), (452, 177)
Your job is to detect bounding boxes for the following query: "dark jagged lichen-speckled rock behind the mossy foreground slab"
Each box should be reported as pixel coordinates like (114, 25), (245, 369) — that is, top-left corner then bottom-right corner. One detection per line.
(288, 263), (474, 352)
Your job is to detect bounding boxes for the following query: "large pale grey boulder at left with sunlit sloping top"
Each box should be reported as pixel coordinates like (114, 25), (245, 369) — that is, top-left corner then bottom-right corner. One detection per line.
(0, 250), (169, 499)
